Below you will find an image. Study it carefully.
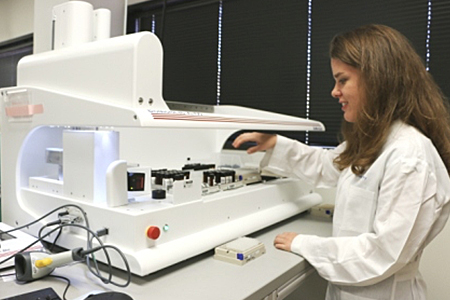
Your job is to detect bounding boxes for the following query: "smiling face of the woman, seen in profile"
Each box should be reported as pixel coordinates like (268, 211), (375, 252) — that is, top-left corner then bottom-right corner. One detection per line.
(331, 58), (362, 123)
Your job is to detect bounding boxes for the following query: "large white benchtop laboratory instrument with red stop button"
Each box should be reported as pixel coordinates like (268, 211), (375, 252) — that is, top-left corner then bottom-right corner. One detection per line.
(0, 1), (324, 276)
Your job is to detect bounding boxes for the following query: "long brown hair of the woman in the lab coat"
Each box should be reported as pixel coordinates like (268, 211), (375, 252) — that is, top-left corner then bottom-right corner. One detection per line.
(330, 25), (450, 175)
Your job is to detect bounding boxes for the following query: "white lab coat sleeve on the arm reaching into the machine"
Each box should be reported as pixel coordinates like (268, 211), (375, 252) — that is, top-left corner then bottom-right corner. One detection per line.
(261, 135), (345, 187)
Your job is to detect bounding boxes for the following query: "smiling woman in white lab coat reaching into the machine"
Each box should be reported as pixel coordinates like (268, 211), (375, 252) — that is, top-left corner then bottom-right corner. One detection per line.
(233, 25), (450, 300)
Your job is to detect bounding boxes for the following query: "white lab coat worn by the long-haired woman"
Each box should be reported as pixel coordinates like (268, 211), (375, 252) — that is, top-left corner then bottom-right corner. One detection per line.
(261, 122), (450, 300)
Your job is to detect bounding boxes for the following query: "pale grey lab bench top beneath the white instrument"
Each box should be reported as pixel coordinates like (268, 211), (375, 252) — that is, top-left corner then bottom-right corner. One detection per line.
(0, 212), (331, 300)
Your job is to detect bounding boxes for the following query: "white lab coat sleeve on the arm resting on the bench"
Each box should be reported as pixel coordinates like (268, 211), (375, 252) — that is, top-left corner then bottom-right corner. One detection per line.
(291, 159), (448, 286)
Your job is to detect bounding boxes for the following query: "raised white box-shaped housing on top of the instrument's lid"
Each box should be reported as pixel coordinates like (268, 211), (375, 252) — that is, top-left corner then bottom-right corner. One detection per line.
(17, 32), (168, 110)
